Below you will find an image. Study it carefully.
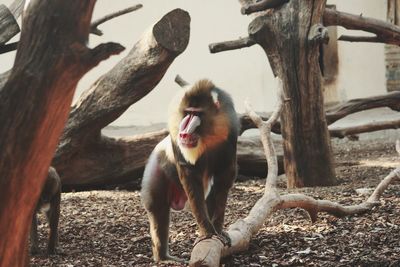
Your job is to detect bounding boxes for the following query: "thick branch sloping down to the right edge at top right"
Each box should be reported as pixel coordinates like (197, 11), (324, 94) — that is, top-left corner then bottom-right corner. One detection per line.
(323, 8), (400, 45)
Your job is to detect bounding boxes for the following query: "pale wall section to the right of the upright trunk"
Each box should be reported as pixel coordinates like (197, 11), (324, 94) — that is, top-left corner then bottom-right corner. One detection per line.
(328, 0), (387, 101)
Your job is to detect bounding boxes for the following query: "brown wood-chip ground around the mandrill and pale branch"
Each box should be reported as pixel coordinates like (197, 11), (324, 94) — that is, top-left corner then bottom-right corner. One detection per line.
(31, 136), (400, 267)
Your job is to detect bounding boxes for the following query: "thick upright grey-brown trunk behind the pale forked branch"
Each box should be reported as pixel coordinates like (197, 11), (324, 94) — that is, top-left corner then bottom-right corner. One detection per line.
(249, 0), (336, 187)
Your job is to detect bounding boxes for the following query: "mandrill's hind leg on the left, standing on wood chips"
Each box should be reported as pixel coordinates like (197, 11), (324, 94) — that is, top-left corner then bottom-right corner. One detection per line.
(141, 155), (183, 262)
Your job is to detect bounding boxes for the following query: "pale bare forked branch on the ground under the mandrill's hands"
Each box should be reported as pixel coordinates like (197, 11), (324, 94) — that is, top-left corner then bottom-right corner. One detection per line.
(190, 77), (400, 266)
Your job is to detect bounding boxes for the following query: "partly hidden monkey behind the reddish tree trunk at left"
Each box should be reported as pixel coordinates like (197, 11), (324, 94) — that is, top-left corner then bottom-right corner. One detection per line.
(30, 167), (61, 254)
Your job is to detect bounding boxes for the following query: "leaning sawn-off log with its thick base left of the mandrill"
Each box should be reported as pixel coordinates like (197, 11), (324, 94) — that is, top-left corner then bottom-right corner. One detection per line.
(53, 9), (190, 191)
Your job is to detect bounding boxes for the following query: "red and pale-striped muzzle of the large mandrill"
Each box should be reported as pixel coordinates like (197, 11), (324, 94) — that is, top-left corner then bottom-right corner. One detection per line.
(178, 114), (201, 148)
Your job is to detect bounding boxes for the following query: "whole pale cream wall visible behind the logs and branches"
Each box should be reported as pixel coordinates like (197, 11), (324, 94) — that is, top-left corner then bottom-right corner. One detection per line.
(0, 0), (386, 126)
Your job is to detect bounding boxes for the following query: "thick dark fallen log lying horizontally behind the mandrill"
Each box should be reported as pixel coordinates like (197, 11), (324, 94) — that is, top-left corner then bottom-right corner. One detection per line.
(59, 130), (284, 192)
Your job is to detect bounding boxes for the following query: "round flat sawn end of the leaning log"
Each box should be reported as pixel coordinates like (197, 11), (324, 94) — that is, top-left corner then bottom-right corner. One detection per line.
(153, 8), (190, 54)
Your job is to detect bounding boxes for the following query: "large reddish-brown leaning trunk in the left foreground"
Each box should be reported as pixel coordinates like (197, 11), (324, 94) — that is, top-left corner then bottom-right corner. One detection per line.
(0, 0), (122, 266)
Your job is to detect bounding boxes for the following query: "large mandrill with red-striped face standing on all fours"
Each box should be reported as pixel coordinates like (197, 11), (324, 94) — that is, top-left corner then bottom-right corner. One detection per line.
(141, 80), (239, 261)
